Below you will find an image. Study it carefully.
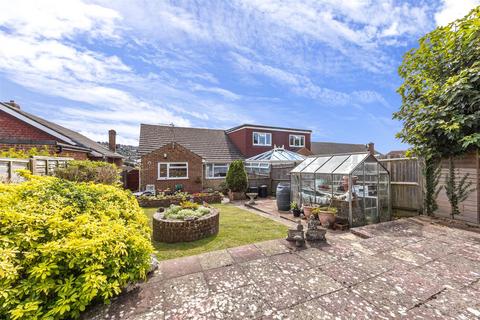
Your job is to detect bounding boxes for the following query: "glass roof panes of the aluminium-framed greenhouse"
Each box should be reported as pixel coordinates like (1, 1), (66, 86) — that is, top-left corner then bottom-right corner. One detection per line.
(291, 153), (376, 174)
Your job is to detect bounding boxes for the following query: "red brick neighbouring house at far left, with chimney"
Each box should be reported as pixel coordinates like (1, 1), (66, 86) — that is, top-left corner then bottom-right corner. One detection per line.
(0, 101), (123, 166)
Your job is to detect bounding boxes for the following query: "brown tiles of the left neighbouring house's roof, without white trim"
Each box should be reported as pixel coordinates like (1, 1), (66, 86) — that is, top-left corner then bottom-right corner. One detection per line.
(0, 102), (123, 158)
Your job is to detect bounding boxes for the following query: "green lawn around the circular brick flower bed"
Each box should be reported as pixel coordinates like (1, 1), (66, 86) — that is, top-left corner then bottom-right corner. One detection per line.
(143, 204), (287, 260)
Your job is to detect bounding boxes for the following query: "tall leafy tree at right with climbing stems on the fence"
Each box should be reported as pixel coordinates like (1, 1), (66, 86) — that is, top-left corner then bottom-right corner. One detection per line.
(394, 7), (480, 216)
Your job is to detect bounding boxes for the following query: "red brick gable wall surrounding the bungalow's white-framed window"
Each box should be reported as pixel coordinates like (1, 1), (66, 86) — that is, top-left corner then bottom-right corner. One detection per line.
(140, 143), (203, 193)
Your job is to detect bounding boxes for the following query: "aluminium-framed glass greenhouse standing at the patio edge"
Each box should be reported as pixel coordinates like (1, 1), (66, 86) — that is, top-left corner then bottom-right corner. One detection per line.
(290, 153), (391, 227)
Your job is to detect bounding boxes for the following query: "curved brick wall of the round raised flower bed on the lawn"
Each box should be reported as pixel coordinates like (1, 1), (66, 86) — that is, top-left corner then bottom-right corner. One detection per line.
(153, 209), (219, 243)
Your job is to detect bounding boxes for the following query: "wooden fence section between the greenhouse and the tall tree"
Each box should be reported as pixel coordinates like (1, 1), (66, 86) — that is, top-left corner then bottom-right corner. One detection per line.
(379, 158), (423, 216)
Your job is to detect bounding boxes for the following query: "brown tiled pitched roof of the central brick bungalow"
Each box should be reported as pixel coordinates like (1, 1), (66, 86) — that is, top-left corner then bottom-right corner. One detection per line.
(138, 124), (244, 162)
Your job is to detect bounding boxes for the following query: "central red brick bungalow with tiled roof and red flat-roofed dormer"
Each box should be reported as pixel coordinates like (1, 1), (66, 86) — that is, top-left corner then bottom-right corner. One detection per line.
(138, 124), (311, 192)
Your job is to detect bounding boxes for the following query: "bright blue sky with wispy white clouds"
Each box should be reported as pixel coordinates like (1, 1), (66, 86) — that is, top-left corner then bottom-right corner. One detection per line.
(0, 0), (480, 152)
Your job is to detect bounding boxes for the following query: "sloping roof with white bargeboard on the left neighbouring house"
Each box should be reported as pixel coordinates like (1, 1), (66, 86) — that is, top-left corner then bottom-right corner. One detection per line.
(0, 102), (123, 158)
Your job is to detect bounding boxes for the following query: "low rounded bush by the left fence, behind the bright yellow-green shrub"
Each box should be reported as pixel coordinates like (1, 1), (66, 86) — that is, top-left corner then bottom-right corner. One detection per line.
(55, 160), (120, 184)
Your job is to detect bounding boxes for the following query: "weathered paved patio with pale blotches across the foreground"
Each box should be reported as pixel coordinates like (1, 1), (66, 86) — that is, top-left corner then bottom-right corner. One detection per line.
(84, 218), (480, 319)
